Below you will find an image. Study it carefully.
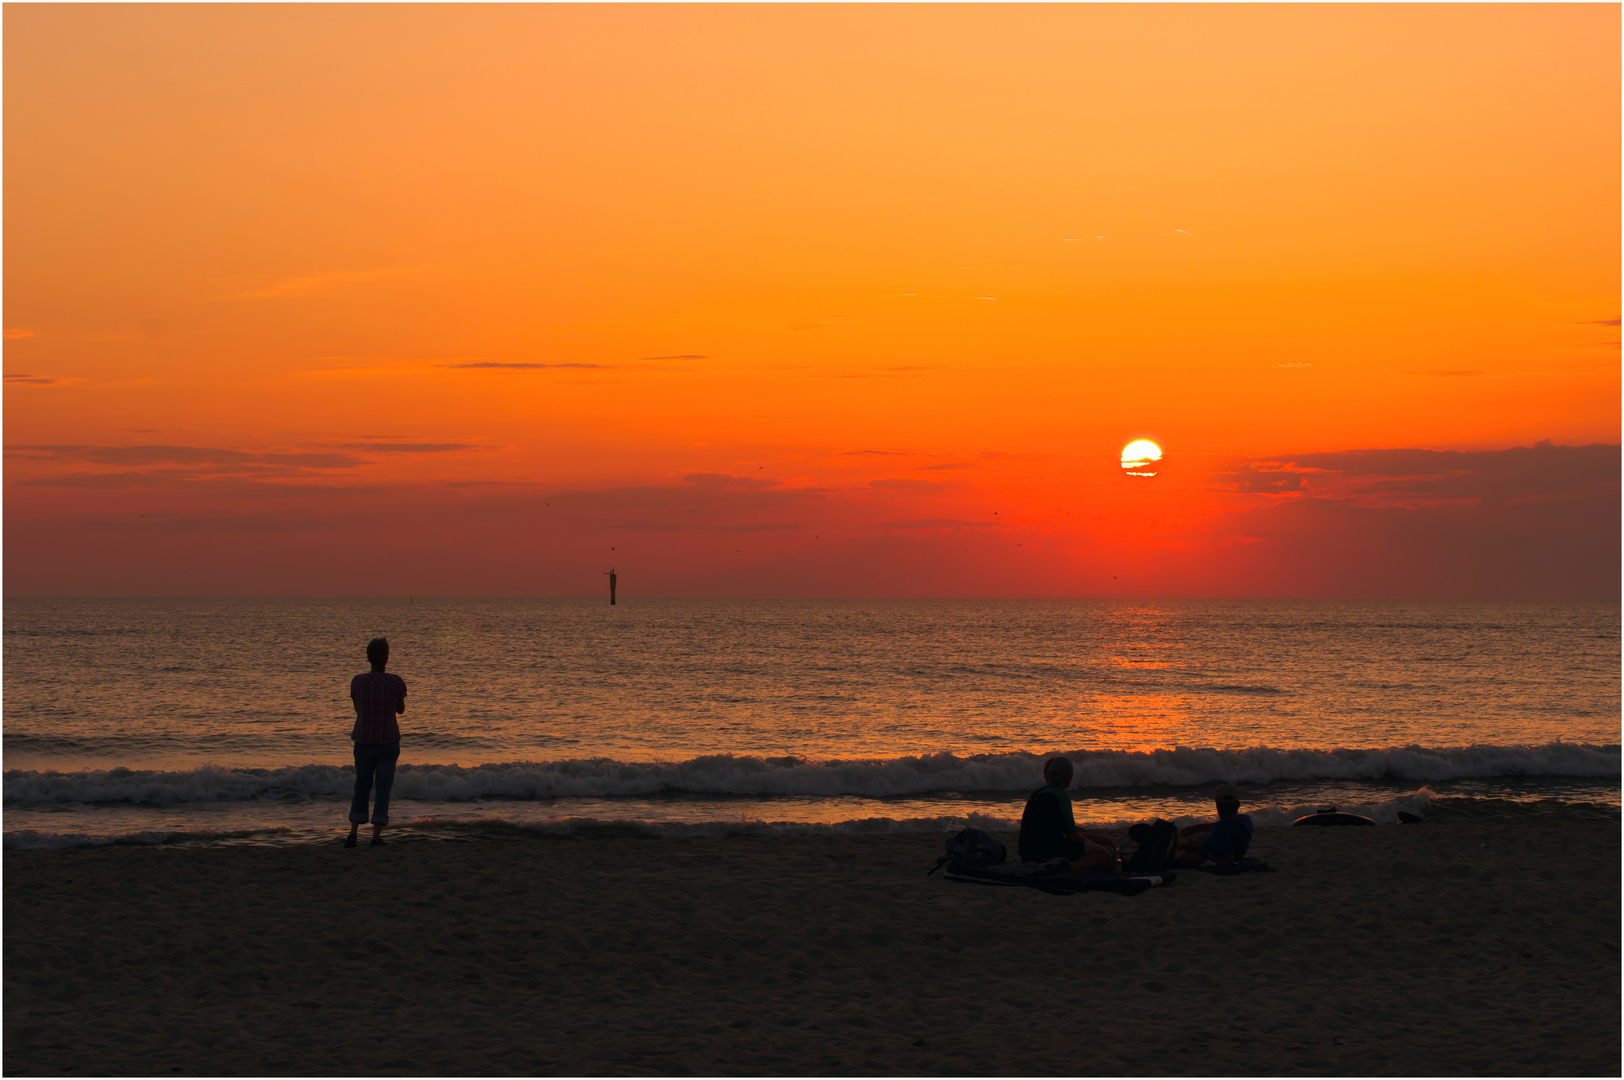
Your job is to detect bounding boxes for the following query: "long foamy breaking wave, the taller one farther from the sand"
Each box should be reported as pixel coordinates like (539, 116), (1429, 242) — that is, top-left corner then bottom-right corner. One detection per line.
(5, 742), (1621, 807)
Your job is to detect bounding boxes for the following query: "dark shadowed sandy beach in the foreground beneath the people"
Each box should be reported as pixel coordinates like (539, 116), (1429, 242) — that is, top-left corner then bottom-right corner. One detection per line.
(5, 812), (1619, 1075)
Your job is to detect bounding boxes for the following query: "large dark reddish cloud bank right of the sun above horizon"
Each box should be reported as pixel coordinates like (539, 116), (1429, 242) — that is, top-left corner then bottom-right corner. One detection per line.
(1189, 442), (1619, 604)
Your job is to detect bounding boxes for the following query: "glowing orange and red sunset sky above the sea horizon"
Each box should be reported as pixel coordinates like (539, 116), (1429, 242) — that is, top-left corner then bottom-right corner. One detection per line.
(3, 5), (1621, 598)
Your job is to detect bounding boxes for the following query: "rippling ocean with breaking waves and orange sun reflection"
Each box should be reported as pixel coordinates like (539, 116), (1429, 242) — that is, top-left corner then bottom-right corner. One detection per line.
(3, 598), (1621, 848)
